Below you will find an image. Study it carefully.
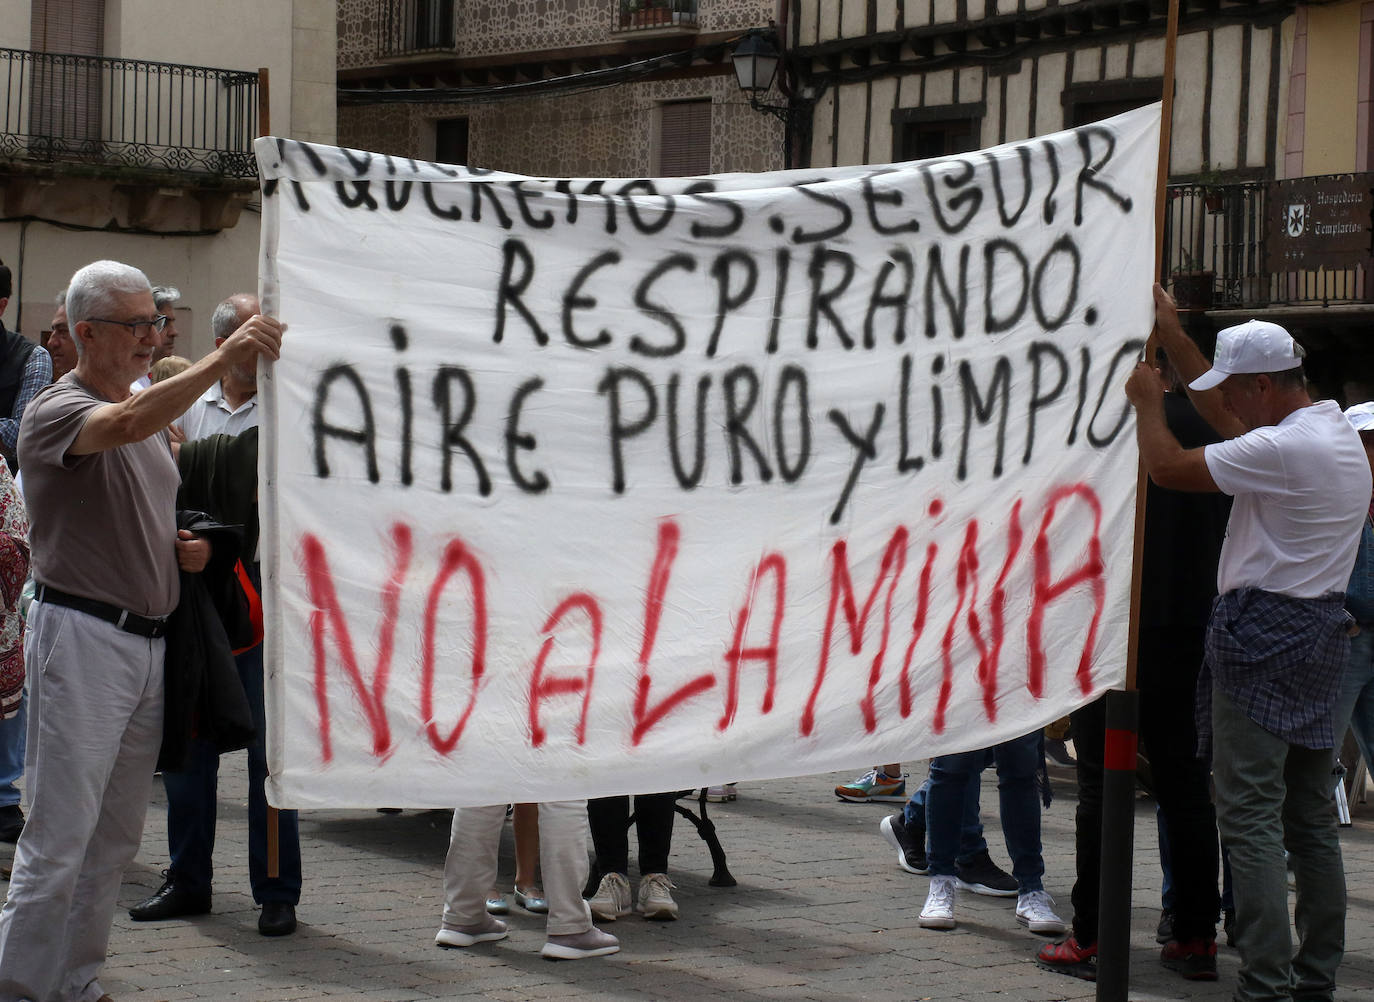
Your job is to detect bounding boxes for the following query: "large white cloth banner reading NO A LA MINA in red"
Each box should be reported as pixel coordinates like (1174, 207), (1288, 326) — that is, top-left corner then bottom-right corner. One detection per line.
(257, 106), (1160, 807)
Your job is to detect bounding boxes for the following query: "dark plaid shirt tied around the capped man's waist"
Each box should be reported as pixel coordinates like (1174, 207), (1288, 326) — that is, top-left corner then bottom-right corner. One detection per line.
(1194, 588), (1353, 757)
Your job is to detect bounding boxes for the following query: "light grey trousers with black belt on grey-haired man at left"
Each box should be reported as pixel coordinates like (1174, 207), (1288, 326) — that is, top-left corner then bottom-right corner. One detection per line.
(0, 602), (166, 1002)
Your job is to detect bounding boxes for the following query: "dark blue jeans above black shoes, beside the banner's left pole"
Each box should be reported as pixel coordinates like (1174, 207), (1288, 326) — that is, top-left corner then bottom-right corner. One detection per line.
(162, 643), (301, 904)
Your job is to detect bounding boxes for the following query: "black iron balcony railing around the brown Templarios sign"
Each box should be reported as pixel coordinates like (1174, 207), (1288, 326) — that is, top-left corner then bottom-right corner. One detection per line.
(1162, 181), (1374, 309)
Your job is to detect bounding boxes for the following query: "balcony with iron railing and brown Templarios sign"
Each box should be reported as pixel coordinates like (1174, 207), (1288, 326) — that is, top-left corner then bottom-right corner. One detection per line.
(1161, 173), (1374, 311)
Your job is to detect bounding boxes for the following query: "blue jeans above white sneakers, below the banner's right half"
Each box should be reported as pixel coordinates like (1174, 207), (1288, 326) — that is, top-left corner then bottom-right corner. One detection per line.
(926, 730), (1044, 893)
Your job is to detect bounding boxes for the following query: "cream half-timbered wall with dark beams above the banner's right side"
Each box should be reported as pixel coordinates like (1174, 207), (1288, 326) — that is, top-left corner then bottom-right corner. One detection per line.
(793, 0), (1291, 177)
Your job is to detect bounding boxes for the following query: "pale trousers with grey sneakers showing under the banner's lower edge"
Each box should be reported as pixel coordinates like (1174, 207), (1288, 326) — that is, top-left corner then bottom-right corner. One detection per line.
(444, 800), (592, 936)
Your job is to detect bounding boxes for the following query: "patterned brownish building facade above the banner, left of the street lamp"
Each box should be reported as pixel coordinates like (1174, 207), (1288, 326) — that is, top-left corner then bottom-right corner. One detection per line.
(338, 0), (783, 177)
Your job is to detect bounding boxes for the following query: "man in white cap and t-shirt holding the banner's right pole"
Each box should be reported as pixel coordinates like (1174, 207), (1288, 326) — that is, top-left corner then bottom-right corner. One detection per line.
(1125, 286), (1370, 1002)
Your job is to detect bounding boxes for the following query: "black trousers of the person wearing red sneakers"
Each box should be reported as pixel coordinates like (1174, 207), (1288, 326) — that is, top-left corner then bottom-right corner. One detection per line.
(1070, 627), (1221, 944)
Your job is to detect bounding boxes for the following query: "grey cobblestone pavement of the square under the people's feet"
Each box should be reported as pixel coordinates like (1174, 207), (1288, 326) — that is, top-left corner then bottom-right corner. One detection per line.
(32, 755), (1374, 1002)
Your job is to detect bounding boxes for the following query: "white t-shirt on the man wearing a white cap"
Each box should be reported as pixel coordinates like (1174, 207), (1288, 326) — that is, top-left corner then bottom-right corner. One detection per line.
(1204, 400), (1370, 598)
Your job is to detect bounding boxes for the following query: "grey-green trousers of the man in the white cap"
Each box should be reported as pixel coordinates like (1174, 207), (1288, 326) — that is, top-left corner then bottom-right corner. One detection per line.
(1212, 687), (1345, 1002)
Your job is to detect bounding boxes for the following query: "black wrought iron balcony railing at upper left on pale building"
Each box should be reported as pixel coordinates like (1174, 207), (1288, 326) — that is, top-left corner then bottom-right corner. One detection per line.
(0, 48), (258, 177)
